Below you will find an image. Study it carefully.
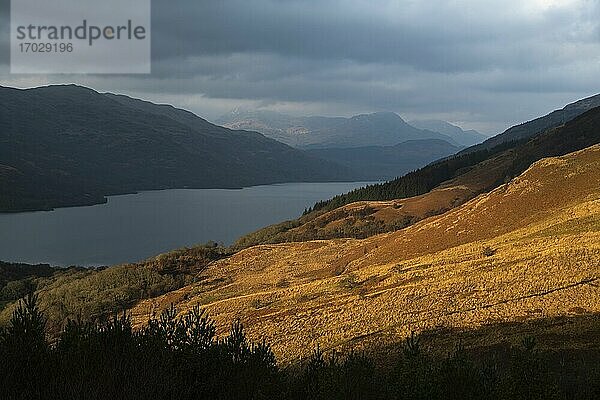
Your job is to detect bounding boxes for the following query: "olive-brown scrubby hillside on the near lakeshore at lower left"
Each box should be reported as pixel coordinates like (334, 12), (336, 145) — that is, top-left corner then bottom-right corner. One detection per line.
(0, 243), (230, 333)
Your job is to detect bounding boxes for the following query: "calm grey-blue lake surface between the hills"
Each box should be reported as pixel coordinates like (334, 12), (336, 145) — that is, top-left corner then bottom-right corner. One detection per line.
(0, 182), (367, 266)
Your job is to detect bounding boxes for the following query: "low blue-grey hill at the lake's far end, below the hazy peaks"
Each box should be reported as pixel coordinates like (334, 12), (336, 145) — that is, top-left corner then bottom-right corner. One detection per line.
(306, 139), (460, 181)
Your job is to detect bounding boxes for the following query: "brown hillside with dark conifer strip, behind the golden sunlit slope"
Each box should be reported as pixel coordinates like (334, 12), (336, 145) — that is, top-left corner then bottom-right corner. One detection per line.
(231, 104), (600, 248)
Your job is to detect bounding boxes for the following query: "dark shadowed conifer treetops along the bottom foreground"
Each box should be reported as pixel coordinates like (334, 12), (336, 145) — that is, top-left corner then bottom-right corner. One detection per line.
(0, 295), (600, 400)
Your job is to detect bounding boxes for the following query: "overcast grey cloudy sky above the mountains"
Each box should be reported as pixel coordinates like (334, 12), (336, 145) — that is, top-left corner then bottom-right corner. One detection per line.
(0, 0), (600, 134)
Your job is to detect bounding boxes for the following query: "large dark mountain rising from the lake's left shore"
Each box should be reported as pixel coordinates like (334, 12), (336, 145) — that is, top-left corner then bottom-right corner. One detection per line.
(0, 85), (351, 211)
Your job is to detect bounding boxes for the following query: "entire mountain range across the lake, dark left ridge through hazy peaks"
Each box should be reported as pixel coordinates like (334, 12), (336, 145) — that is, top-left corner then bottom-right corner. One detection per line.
(0, 85), (488, 212)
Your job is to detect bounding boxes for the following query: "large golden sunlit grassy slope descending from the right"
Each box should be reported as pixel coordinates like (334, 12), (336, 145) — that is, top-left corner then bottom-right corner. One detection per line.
(133, 145), (600, 359)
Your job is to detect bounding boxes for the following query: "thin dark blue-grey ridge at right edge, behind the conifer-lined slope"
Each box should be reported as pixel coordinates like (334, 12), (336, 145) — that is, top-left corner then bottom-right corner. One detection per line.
(461, 94), (600, 154)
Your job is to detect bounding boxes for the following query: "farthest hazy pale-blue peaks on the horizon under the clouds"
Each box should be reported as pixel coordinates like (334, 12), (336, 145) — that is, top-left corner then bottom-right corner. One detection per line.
(216, 110), (459, 149)
